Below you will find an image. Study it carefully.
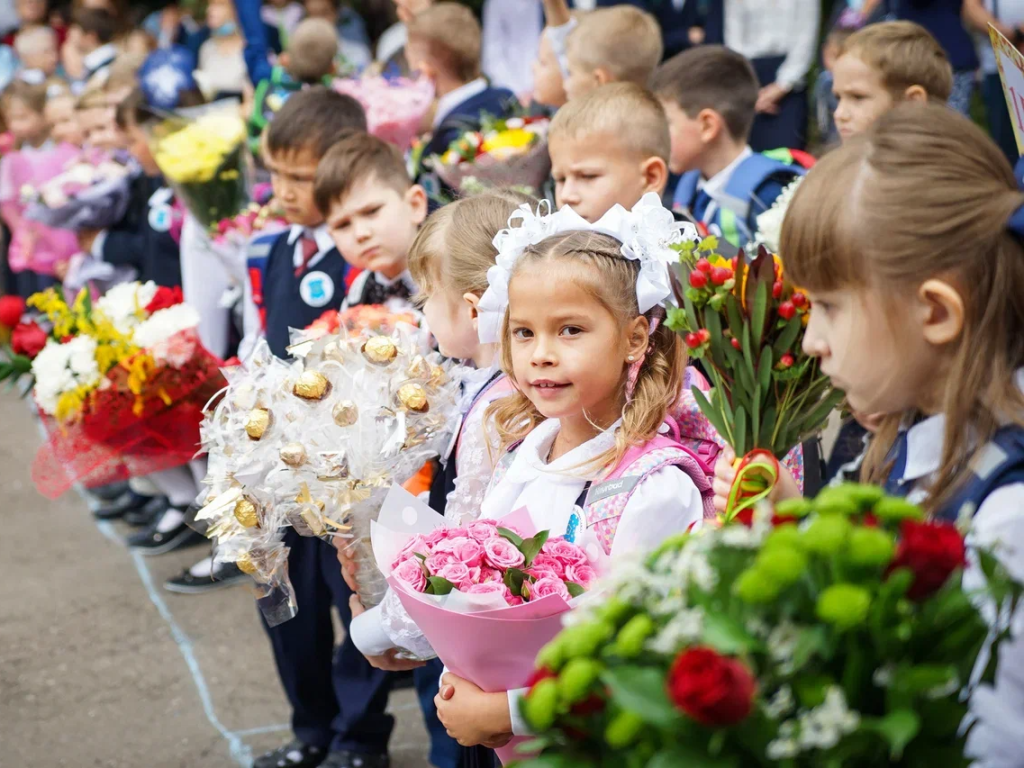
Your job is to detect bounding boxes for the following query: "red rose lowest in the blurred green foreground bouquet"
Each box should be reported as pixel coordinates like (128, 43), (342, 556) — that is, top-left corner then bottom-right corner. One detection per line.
(668, 647), (756, 728)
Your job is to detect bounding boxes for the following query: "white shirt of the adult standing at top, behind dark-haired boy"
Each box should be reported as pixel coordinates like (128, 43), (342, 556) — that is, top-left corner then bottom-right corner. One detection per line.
(724, 0), (821, 89)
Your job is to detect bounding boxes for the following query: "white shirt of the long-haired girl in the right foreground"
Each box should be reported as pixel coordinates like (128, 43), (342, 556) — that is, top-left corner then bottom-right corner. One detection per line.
(872, 391), (1024, 768)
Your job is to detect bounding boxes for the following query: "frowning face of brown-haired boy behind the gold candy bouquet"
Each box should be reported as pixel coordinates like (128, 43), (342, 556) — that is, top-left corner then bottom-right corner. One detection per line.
(327, 174), (427, 280)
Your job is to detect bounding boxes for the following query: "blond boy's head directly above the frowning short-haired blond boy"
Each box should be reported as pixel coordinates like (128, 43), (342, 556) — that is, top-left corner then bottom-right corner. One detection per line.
(555, 5), (665, 100)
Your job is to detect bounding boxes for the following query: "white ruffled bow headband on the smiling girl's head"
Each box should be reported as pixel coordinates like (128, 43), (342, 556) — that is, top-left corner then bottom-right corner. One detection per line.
(478, 193), (697, 344)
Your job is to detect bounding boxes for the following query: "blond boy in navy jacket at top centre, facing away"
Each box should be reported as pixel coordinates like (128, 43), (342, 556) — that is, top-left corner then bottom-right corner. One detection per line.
(406, 2), (518, 200)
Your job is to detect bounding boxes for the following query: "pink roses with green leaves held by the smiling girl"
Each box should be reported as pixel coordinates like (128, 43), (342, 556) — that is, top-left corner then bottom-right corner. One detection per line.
(391, 520), (597, 605)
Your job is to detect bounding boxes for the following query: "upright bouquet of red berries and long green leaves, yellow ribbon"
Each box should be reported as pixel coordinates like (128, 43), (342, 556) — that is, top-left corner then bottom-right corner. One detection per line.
(668, 238), (843, 517)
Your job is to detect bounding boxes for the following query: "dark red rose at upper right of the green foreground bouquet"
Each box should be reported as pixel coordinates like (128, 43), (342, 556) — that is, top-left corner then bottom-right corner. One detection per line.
(889, 520), (967, 600)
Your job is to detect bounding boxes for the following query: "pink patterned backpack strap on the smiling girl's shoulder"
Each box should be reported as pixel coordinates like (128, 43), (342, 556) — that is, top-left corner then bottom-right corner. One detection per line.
(584, 435), (715, 552)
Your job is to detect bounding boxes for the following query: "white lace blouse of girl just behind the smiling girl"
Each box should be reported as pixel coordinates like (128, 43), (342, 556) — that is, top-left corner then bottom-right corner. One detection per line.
(348, 364), (507, 658)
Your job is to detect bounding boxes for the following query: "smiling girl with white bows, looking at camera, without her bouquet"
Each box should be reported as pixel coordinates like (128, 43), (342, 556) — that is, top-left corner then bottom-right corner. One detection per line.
(437, 195), (713, 746)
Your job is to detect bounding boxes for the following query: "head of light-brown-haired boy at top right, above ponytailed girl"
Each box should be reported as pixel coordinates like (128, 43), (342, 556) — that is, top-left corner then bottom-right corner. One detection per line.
(833, 22), (953, 141)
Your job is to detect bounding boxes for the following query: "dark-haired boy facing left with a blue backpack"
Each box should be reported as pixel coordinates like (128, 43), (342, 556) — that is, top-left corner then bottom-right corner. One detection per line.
(651, 45), (804, 248)
